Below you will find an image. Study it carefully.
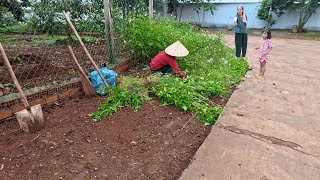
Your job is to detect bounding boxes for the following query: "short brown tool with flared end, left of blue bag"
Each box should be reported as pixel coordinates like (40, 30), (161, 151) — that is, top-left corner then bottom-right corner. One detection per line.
(68, 46), (97, 96)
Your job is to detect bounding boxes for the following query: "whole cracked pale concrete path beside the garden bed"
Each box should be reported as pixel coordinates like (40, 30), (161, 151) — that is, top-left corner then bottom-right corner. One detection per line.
(180, 36), (320, 180)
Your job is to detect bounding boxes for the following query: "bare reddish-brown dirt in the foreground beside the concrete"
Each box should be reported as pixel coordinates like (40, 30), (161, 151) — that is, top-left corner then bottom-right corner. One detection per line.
(0, 98), (211, 180)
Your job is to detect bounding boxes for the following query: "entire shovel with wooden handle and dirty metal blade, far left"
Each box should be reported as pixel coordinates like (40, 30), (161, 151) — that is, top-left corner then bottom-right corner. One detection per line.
(0, 43), (44, 132)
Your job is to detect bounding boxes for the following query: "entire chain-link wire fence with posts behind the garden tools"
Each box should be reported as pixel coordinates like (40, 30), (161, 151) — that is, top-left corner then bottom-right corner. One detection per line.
(0, 0), (168, 116)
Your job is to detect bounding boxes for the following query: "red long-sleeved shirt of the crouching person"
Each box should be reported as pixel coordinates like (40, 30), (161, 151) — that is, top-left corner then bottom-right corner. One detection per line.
(150, 51), (187, 78)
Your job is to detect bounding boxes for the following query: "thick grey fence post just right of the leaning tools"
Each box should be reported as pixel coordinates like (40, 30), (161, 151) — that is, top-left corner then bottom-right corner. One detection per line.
(103, 0), (116, 63)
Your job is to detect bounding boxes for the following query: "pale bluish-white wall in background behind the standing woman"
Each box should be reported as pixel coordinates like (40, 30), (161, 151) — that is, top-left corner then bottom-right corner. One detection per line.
(178, 2), (320, 31)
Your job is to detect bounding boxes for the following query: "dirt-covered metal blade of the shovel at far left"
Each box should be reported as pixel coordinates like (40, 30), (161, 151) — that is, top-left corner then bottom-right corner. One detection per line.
(15, 104), (44, 133)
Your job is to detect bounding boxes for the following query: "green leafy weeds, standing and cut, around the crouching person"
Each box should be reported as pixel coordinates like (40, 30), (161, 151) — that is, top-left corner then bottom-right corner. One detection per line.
(90, 18), (248, 125)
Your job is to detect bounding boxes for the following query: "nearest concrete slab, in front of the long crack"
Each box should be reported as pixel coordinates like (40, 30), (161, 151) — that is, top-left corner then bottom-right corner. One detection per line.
(180, 126), (320, 180)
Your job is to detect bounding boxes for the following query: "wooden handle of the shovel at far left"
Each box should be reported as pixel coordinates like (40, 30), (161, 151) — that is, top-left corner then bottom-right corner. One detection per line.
(0, 42), (30, 109)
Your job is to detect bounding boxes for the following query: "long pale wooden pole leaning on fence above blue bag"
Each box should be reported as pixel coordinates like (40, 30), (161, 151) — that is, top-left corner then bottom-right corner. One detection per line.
(62, 11), (109, 90)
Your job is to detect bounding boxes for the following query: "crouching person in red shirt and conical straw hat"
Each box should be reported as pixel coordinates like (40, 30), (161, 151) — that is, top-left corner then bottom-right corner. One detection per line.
(150, 41), (189, 78)
